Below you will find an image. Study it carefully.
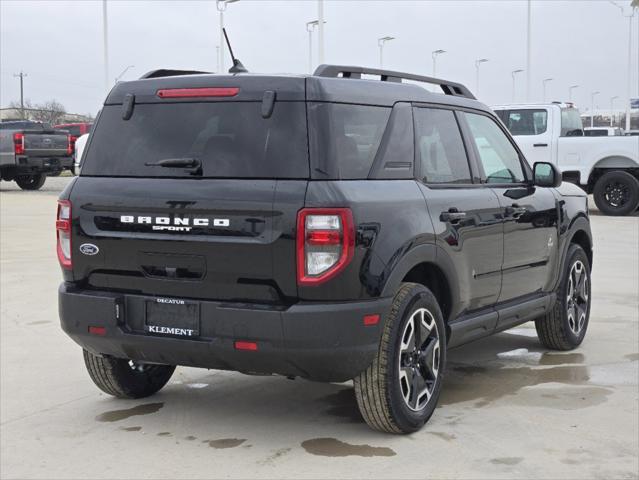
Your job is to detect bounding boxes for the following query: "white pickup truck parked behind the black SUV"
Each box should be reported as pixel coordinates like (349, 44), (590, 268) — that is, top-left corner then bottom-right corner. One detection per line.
(492, 103), (639, 215)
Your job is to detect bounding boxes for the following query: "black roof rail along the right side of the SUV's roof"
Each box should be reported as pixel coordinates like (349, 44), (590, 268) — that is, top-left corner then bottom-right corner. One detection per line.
(313, 65), (475, 100)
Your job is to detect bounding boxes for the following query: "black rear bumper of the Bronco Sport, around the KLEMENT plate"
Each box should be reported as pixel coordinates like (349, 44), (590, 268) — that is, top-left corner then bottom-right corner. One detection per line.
(59, 283), (392, 382)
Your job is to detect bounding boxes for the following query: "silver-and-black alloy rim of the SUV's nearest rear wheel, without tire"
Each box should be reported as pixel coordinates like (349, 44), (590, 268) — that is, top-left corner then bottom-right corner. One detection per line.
(398, 308), (440, 411)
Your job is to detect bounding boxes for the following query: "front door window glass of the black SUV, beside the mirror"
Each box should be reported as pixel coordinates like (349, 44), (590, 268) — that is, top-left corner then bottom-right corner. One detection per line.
(464, 113), (525, 183)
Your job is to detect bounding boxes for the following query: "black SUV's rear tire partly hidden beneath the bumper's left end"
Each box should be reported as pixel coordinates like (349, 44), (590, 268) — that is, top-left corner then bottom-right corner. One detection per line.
(83, 350), (175, 398)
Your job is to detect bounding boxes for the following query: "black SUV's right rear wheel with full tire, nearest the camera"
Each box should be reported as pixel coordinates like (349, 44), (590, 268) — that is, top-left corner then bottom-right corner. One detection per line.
(353, 283), (446, 433)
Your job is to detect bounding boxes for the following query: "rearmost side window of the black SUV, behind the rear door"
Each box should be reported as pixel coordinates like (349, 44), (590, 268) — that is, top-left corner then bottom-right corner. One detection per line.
(309, 103), (391, 180)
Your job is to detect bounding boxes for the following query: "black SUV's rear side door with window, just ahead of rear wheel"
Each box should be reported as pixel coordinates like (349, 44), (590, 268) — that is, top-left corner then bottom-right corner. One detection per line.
(413, 107), (503, 311)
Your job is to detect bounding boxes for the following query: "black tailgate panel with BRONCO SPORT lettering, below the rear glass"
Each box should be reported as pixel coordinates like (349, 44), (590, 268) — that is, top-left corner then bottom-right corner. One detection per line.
(70, 177), (307, 303)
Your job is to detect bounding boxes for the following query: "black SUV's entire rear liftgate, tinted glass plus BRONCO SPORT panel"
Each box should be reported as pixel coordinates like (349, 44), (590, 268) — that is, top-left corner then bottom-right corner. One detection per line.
(71, 94), (309, 303)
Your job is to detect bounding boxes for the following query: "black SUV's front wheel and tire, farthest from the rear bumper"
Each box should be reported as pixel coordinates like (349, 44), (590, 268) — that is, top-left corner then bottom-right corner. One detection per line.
(535, 243), (591, 350)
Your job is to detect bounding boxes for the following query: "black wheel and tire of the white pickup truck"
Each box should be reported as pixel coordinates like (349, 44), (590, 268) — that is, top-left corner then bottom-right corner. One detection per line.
(593, 170), (639, 215)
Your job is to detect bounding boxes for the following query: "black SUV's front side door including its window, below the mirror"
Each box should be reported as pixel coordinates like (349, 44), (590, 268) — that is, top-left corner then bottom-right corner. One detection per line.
(463, 112), (558, 302)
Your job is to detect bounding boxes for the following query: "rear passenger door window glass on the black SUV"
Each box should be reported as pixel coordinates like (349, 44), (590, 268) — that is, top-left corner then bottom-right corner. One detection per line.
(414, 108), (471, 183)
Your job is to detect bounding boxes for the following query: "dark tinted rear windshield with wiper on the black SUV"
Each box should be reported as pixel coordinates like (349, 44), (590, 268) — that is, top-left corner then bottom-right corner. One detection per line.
(82, 102), (309, 178)
